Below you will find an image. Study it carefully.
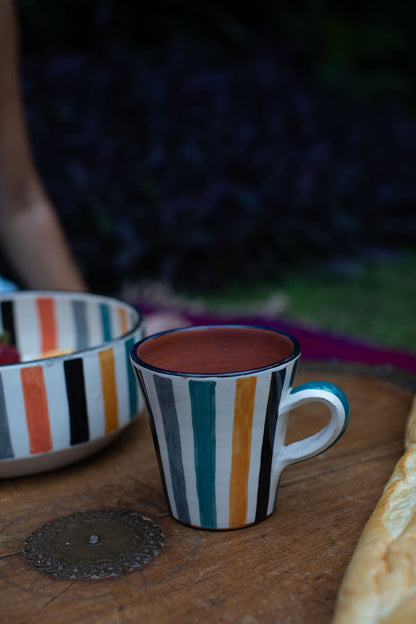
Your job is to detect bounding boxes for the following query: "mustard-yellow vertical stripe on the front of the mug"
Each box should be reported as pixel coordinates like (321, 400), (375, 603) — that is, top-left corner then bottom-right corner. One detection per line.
(230, 377), (257, 526)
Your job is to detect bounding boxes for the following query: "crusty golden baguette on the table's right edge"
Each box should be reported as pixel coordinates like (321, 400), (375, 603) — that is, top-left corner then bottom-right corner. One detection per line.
(333, 398), (416, 624)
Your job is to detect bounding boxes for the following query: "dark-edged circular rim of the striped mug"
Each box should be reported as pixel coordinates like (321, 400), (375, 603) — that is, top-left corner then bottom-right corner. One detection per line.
(130, 323), (301, 379)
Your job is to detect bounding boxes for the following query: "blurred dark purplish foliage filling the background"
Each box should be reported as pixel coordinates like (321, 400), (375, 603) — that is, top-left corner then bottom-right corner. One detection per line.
(5, 0), (416, 292)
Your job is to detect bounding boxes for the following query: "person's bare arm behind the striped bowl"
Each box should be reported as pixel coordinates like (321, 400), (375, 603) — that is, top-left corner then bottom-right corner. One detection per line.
(0, 0), (86, 290)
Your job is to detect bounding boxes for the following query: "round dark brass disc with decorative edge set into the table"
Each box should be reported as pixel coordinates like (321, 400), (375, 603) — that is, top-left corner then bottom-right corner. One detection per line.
(23, 509), (163, 579)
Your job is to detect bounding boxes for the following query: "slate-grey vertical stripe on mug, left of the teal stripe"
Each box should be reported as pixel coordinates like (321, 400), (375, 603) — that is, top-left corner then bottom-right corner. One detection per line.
(153, 375), (190, 524)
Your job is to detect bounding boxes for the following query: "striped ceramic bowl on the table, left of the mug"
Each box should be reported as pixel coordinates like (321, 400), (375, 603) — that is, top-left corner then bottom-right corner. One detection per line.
(0, 291), (144, 478)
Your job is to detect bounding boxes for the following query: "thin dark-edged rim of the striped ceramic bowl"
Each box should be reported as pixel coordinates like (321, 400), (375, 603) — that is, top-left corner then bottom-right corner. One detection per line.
(0, 289), (144, 371)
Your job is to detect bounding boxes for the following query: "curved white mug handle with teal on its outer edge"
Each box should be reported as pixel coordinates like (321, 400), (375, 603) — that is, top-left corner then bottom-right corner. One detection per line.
(279, 381), (350, 466)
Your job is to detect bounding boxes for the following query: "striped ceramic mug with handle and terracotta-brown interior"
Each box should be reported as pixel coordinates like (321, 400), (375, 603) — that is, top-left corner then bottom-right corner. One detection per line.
(130, 325), (349, 529)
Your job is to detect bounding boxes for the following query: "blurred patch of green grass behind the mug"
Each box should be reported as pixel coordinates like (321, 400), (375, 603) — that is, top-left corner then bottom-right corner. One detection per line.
(200, 253), (416, 350)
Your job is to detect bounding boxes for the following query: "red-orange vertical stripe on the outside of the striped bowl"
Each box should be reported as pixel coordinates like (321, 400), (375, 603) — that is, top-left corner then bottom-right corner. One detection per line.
(20, 366), (52, 453)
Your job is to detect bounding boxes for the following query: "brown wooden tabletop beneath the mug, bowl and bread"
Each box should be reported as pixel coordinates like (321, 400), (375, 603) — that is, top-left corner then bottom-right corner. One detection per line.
(0, 364), (415, 624)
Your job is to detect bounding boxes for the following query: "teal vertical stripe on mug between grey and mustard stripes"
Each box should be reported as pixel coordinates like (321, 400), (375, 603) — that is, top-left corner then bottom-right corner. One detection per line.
(189, 379), (217, 529)
